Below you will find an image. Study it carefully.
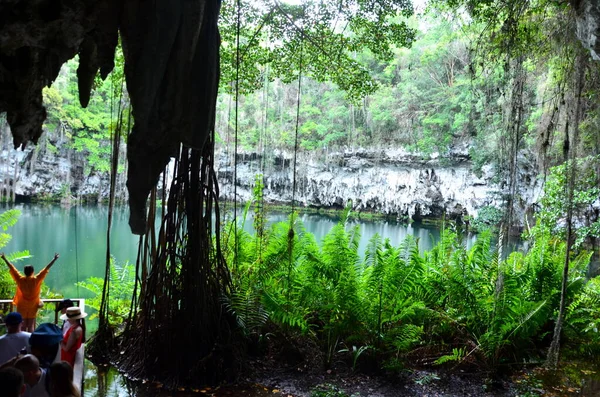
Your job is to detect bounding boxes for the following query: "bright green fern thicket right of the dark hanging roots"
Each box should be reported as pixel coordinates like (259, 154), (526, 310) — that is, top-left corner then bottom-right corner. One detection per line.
(223, 203), (597, 367)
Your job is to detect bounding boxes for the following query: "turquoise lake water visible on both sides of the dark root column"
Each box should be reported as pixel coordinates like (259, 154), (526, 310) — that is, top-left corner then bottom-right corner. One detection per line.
(2, 204), (468, 298)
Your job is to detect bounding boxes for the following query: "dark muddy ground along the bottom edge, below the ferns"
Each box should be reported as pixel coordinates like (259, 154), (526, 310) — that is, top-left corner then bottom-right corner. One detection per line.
(104, 332), (600, 397)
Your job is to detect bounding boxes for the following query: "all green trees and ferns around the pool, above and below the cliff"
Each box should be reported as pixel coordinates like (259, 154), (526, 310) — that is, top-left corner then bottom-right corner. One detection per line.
(3, 0), (600, 392)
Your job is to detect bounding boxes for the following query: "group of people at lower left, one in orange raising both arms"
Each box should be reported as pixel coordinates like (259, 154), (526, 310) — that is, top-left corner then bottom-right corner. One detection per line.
(0, 254), (87, 397)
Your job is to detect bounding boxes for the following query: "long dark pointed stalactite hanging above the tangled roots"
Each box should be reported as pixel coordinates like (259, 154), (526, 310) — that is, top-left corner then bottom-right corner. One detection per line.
(121, 0), (220, 234)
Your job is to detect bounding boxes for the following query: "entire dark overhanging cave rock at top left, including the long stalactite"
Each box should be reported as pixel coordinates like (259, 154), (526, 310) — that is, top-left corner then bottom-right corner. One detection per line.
(0, 0), (220, 234)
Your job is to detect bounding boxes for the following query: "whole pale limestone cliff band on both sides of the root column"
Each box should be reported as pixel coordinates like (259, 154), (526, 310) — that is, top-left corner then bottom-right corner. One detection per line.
(0, 142), (541, 223)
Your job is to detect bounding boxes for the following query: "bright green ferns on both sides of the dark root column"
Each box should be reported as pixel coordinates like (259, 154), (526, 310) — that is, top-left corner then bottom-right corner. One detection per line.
(70, 197), (600, 373)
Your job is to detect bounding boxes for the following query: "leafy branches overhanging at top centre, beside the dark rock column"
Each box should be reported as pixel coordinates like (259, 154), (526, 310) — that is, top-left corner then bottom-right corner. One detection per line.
(221, 0), (415, 100)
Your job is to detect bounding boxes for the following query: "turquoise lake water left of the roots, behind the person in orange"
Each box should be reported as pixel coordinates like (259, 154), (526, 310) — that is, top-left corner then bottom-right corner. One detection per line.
(3, 204), (138, 298)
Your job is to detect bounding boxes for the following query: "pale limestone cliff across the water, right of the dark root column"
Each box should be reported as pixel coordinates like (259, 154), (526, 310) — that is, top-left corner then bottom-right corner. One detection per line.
(218, 149), (541, 219)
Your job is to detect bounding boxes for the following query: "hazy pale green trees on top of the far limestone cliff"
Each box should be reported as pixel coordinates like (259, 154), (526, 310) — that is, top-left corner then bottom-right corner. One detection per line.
(217, 12), (502, 160)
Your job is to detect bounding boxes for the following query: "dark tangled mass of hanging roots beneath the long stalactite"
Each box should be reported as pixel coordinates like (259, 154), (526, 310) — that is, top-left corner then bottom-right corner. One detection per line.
(119, 141), (243, 388)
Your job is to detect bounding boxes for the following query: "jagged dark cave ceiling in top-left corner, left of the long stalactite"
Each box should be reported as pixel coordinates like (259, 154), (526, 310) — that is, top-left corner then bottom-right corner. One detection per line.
(0, 0), (119, 147)
